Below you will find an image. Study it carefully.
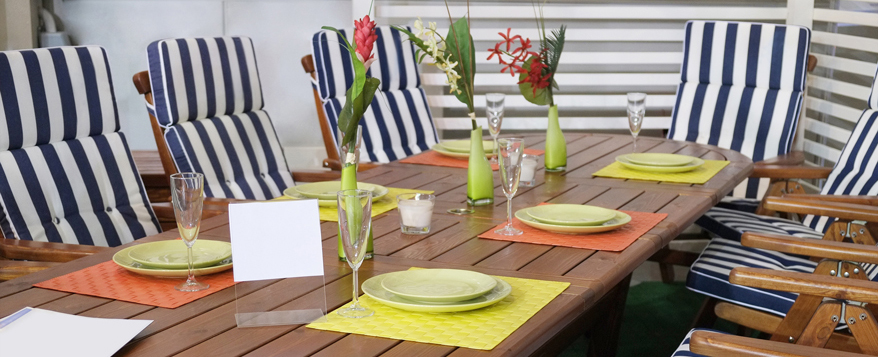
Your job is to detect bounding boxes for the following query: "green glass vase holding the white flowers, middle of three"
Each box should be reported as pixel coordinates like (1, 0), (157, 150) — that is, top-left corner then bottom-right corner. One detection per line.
(466, 127), (494, 206)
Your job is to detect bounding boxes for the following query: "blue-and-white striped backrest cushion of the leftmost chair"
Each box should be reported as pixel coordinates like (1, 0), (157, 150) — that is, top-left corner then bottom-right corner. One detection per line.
(0, 46), (161, 246)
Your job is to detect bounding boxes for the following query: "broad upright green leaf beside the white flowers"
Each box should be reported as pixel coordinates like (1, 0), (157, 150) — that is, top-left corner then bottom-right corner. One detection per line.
(445, 17), (476, 113)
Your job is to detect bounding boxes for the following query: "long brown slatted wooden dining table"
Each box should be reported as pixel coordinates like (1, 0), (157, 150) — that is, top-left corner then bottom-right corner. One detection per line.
(0, 133), (753, 356)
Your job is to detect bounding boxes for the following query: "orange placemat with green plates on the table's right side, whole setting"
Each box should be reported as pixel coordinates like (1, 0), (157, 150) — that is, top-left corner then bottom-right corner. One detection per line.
(479, 203), (668, 251)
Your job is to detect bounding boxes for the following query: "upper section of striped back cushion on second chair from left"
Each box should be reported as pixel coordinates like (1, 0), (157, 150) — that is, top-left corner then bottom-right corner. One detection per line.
(146, 37), (263, 126)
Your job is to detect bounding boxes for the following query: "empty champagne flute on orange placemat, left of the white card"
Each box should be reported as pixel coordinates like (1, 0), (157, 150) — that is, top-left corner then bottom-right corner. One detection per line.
(171, 172), (210, 291)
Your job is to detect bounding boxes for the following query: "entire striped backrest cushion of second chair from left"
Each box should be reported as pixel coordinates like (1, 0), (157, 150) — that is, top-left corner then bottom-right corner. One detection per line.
(146, 37), (294, 199)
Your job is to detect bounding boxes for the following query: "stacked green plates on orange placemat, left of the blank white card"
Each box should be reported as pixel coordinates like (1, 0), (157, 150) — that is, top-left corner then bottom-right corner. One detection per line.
(113, 240), (232, 278)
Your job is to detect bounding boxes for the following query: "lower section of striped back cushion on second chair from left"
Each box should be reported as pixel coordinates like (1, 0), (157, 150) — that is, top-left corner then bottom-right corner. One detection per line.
(165, 110), (293, 200)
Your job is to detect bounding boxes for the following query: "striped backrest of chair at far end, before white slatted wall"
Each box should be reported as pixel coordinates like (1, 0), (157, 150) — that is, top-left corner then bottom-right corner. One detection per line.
(668, 21), (811, 198)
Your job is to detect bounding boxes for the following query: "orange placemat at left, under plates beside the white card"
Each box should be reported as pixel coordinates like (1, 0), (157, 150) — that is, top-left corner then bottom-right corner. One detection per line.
(34, 260), (235, 309)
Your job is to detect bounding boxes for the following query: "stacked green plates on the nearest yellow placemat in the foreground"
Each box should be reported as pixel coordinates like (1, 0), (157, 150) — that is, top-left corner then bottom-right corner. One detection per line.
(363, 269), (512, 312)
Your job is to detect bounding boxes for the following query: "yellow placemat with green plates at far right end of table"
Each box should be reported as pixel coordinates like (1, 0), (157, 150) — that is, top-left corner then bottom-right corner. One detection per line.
(592, 153), (729, 184)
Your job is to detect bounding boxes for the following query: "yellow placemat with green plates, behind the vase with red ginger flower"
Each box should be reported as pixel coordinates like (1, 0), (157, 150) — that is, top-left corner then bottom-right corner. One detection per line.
(275, 181), (433, 222)
